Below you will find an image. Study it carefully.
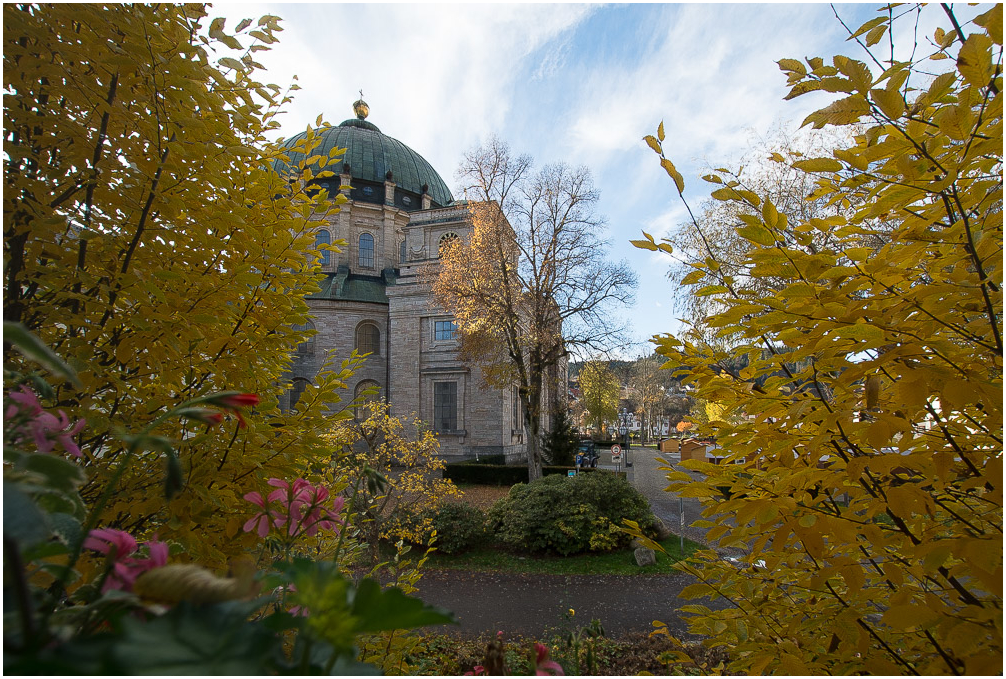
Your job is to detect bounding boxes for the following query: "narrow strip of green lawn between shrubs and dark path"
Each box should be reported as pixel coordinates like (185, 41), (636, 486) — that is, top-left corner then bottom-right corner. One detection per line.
(426, 535), (702, 575)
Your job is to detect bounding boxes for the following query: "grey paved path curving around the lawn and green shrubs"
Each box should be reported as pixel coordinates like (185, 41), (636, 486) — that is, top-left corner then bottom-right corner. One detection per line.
(417, 447), (740, 639)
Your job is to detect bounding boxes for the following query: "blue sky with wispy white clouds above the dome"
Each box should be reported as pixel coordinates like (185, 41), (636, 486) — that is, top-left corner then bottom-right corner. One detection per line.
(209, 3), (974, 357)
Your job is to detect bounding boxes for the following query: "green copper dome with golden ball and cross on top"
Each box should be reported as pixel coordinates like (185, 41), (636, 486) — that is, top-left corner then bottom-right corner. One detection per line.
(277, 99), (454, 210)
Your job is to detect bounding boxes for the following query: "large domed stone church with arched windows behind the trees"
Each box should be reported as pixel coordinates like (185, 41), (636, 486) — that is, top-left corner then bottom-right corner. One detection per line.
(284, 100), (539, 461)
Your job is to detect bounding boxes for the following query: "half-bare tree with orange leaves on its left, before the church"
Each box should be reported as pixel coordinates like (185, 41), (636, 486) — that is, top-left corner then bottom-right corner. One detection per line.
(428, 139), (636, 480)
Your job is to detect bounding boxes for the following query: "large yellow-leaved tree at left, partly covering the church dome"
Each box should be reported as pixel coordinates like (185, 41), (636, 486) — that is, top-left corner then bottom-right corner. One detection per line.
(3, 4), (351, 565)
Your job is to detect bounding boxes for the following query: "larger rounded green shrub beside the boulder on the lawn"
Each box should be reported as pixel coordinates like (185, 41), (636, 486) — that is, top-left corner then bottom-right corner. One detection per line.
(488, 473), (656, 555)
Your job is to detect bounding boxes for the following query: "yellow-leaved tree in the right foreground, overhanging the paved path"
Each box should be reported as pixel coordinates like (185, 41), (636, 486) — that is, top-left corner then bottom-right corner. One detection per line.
(637, 5), (1003, 675)
